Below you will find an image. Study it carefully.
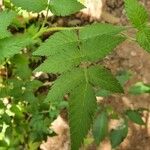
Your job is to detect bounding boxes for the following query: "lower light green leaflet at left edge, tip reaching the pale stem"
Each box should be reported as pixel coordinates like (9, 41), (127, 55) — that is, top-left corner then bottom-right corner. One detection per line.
(0, 35), (32, 63)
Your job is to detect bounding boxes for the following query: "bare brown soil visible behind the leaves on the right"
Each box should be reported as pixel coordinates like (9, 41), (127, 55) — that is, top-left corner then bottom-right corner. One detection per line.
(99, 0), (150, 150)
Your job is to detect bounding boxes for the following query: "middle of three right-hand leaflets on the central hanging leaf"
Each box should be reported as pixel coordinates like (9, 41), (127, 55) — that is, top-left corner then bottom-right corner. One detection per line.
(81, 35), (125, 61)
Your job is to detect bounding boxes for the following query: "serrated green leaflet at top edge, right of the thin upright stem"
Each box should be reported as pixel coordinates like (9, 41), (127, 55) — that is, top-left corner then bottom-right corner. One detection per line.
(50, 0), (84, 16)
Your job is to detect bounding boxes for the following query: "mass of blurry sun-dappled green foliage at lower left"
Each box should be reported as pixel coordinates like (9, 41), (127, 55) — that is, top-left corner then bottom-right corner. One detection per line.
(0, 54), (51, 146)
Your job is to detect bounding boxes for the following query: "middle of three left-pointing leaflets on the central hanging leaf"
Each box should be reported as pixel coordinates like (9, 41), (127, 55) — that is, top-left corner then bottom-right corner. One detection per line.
(35, 47), (81, 73)
